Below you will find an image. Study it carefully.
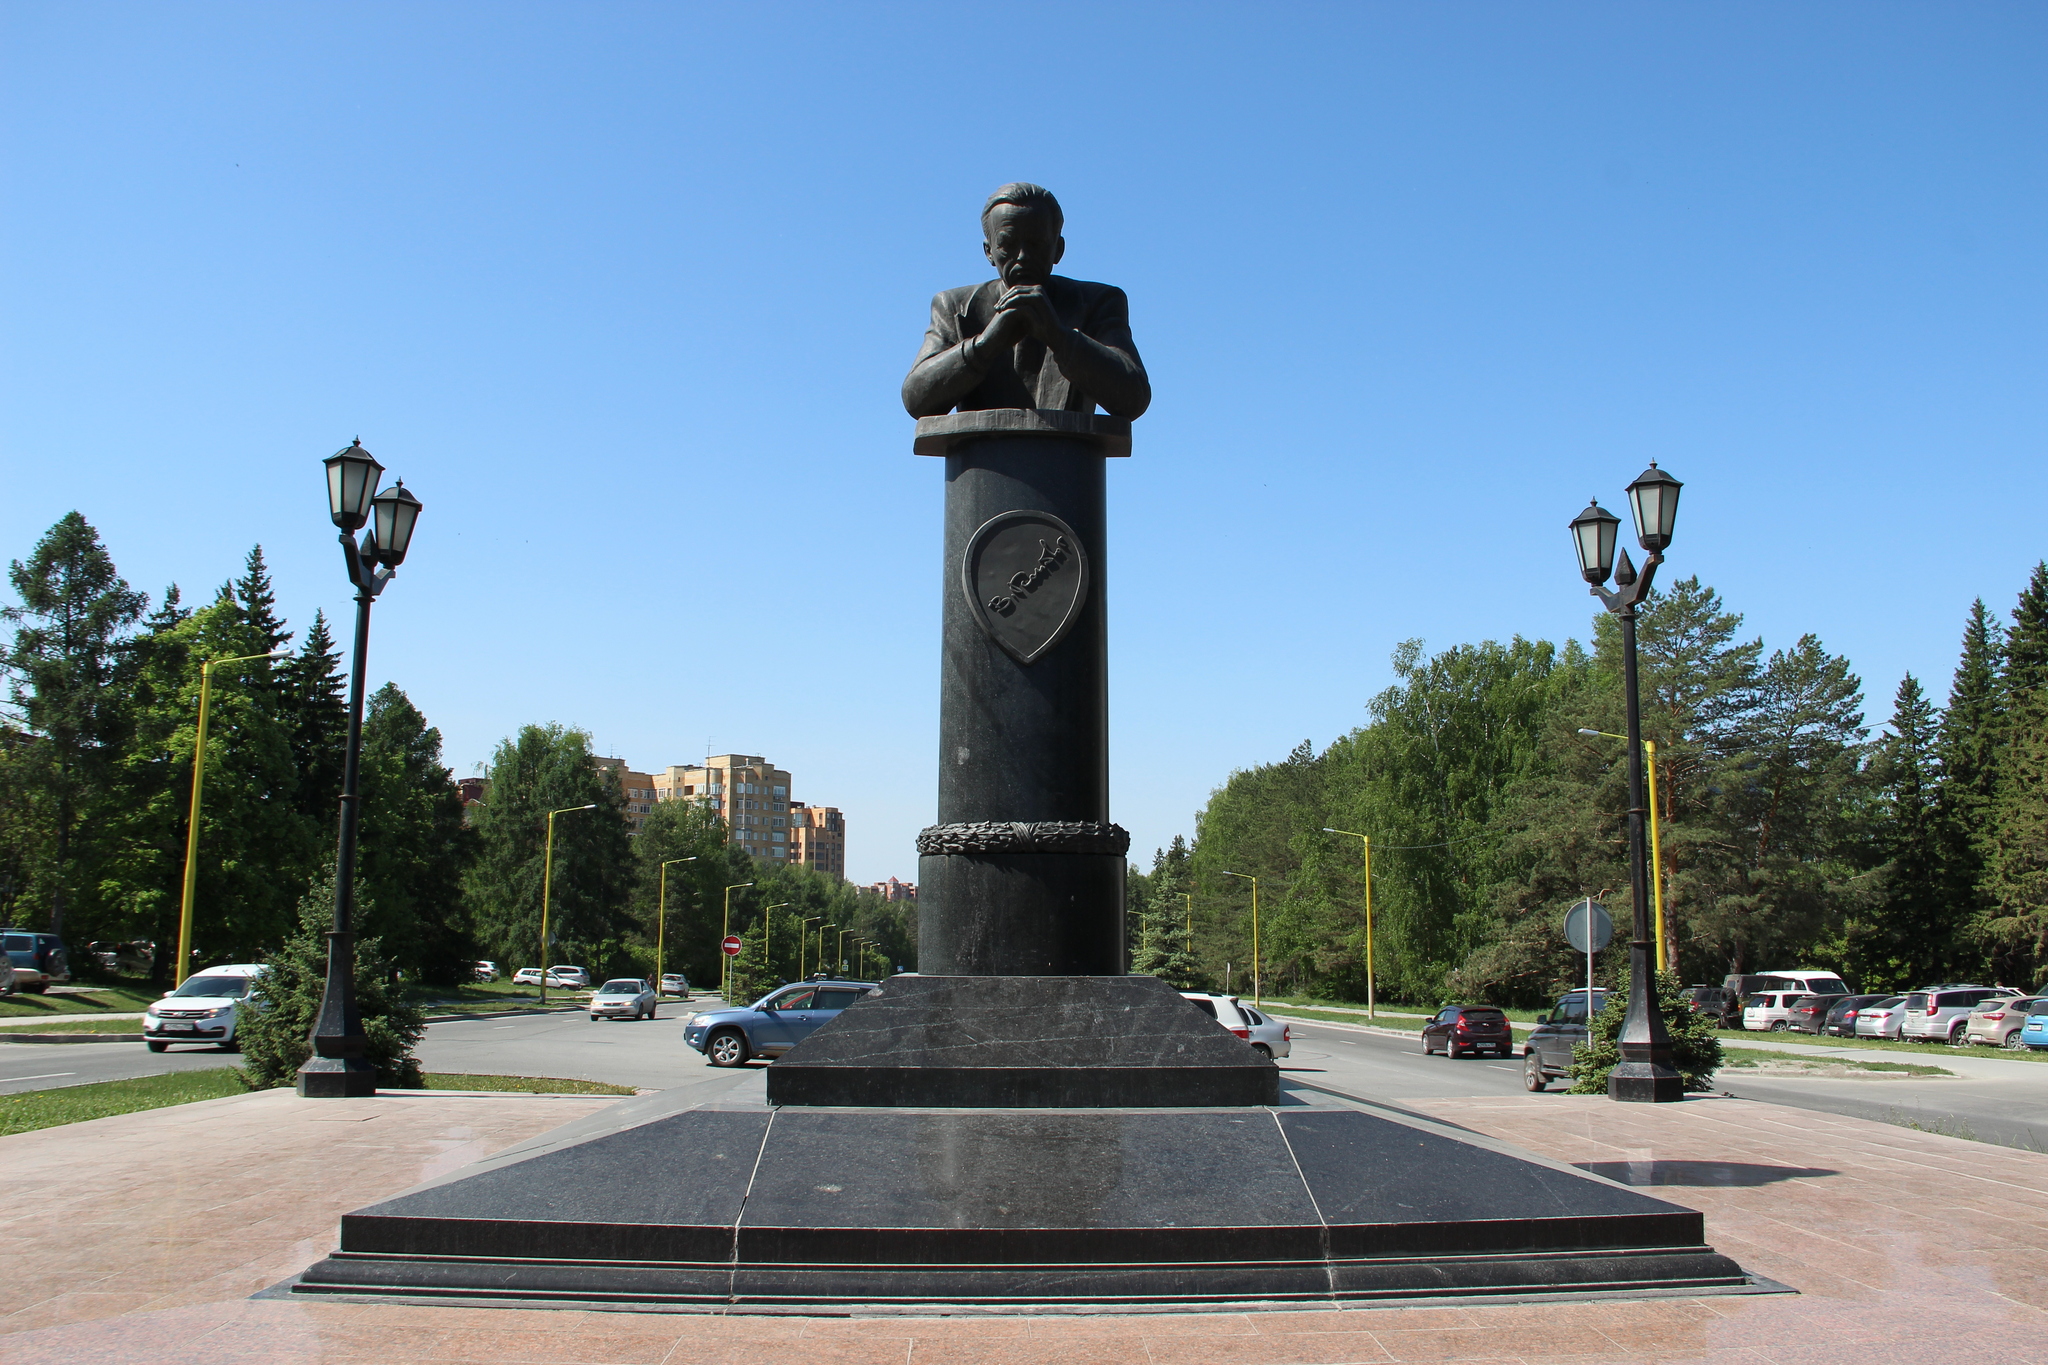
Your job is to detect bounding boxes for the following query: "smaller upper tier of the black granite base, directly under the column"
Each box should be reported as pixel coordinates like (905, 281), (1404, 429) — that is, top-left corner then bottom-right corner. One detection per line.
(768, 976), (1280, 1109)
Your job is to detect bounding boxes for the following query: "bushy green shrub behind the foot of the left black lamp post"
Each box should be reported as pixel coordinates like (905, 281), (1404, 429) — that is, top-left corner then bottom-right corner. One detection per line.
(236, 874), (426, 1091)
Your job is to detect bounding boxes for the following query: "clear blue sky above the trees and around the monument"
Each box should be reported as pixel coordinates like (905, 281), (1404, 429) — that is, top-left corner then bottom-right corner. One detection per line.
(0, 0), (2048, 880)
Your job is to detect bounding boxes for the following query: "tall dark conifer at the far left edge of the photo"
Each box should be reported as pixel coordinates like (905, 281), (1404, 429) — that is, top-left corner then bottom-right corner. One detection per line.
(0, 512), (150, 933)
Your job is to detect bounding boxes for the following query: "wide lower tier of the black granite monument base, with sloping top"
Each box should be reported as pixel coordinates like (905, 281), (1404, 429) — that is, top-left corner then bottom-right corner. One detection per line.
(289, 1103), (1757, 1312)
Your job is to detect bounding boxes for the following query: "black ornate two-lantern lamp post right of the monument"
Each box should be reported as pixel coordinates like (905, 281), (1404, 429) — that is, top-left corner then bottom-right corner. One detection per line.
(1571, 463), (1686, 1103)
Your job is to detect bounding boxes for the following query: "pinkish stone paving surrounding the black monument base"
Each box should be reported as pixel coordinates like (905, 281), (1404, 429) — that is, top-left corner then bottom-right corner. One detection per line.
(0, 1091), (2048, 1365)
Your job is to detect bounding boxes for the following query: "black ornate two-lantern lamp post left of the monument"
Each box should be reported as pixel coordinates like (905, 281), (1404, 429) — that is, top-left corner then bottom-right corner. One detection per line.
(299, 440), (420, 1099)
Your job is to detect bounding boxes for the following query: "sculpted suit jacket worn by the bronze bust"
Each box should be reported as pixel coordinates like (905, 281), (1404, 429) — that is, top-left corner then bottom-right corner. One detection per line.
(903, 274), (1151, 417)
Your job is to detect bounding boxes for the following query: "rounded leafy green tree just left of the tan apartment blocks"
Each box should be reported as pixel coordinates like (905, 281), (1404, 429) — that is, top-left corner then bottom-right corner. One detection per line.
(465, 724), (637, 968)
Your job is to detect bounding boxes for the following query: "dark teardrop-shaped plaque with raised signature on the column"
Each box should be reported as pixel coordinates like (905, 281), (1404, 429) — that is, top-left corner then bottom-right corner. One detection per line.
(961, 512), (1087, 663)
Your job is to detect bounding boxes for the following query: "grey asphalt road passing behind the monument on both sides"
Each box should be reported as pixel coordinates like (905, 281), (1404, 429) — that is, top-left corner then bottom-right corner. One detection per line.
(12, 997), (2048, 1152)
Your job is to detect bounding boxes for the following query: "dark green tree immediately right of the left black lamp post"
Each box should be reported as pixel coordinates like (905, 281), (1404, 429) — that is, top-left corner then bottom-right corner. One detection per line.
(358, 684), (477, 984)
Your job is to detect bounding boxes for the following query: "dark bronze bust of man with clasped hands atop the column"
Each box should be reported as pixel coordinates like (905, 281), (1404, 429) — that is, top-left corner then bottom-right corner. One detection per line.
(903, 184), (1151, 420)
